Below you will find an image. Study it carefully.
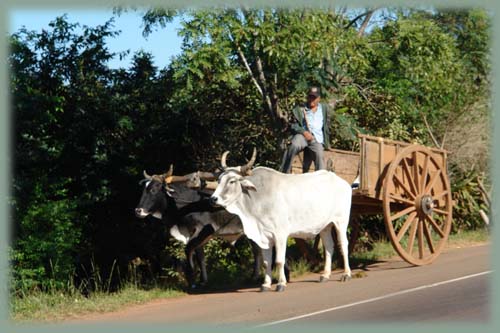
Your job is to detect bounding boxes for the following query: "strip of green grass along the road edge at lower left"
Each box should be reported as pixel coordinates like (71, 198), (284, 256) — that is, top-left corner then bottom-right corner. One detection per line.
(11, 285), (184, 322)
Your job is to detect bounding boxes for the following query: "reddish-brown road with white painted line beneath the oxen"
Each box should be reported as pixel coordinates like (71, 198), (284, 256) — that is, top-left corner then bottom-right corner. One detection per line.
(72, 245), (491, 328)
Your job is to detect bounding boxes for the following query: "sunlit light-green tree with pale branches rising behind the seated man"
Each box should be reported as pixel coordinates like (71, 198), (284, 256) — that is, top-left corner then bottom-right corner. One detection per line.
(144, 7), (373, 128)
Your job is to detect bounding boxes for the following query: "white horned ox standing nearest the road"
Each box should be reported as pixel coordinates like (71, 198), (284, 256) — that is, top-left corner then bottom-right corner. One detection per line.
(211, 150), (352, 291)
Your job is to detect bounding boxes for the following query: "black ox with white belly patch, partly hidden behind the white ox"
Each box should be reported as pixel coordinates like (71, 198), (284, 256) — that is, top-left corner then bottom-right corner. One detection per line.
(135, 167), (262, 288)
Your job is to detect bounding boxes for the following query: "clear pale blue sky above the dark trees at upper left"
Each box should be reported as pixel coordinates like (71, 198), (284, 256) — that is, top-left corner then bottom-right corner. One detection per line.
(9, 8), (181, 68)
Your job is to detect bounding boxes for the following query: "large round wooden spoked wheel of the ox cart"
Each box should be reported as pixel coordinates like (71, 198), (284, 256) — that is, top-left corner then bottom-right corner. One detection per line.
(383, 145), (453, 265)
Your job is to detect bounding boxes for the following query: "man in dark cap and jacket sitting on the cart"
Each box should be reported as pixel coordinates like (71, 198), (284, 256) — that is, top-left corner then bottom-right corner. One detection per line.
(281, 86), (330, 173)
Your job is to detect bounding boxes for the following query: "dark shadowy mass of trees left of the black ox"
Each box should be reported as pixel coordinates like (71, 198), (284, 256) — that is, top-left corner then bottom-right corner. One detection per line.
(10, 17), (178, 296)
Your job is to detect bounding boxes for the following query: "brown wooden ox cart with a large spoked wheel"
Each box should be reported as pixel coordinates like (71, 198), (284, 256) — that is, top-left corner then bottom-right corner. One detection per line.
(292, 135), (453, 265)
